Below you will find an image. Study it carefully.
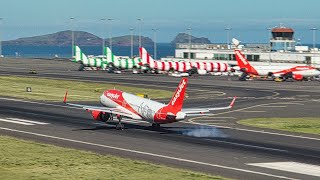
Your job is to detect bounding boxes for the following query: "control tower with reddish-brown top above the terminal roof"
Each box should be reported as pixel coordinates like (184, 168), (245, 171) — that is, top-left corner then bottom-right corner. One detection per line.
(270, 25), (296, 51)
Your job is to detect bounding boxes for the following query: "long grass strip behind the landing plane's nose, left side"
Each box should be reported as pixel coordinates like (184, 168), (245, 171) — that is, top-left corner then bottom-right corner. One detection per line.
(0, 76), (173, 101)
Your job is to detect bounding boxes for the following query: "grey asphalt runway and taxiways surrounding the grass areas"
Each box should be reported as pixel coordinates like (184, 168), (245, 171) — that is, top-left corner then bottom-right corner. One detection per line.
(0, 60), (320, 179)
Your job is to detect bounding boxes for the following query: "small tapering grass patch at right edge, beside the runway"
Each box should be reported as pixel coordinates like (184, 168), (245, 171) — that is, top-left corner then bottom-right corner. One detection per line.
(238, 117), (320, 135)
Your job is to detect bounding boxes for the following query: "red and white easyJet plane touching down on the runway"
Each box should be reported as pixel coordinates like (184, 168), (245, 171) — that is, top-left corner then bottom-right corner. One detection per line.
(63, 78), (236, 129)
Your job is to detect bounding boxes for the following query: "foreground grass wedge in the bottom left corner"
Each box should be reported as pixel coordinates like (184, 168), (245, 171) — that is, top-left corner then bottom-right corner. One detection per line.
(0, 136), (224, 180)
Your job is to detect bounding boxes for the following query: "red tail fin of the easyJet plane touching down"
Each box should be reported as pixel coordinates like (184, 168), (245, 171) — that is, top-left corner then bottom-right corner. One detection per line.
(168, 78), (188, 112)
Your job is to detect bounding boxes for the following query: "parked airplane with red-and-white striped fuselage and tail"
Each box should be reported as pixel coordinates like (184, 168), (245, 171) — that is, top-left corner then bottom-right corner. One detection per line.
(139, 48), (231, 74)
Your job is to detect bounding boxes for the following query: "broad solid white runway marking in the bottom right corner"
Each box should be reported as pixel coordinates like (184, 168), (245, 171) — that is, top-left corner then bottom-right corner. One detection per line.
(248, 162), (320, 177)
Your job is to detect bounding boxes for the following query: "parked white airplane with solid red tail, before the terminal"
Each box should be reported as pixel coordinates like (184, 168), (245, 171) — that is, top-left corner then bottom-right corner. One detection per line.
(232, 38), (320, 80)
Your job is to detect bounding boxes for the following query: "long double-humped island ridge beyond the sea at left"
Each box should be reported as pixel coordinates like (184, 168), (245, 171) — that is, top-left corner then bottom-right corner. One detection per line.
(3, 31), (153, 46)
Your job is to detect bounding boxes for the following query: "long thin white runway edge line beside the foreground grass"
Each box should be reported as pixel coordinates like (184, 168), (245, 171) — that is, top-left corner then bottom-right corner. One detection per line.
(0, 127), (294, 179)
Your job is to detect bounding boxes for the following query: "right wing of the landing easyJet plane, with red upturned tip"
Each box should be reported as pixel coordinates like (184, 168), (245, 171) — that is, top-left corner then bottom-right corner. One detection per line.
(182, 96), (237, 116)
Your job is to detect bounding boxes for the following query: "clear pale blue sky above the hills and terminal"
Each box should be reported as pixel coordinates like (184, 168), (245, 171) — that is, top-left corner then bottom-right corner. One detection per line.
(0, 0), (320, 43)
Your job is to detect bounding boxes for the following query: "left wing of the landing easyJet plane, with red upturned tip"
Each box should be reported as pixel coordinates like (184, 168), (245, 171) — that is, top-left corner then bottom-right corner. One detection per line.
(63, 91), (133, 119)
